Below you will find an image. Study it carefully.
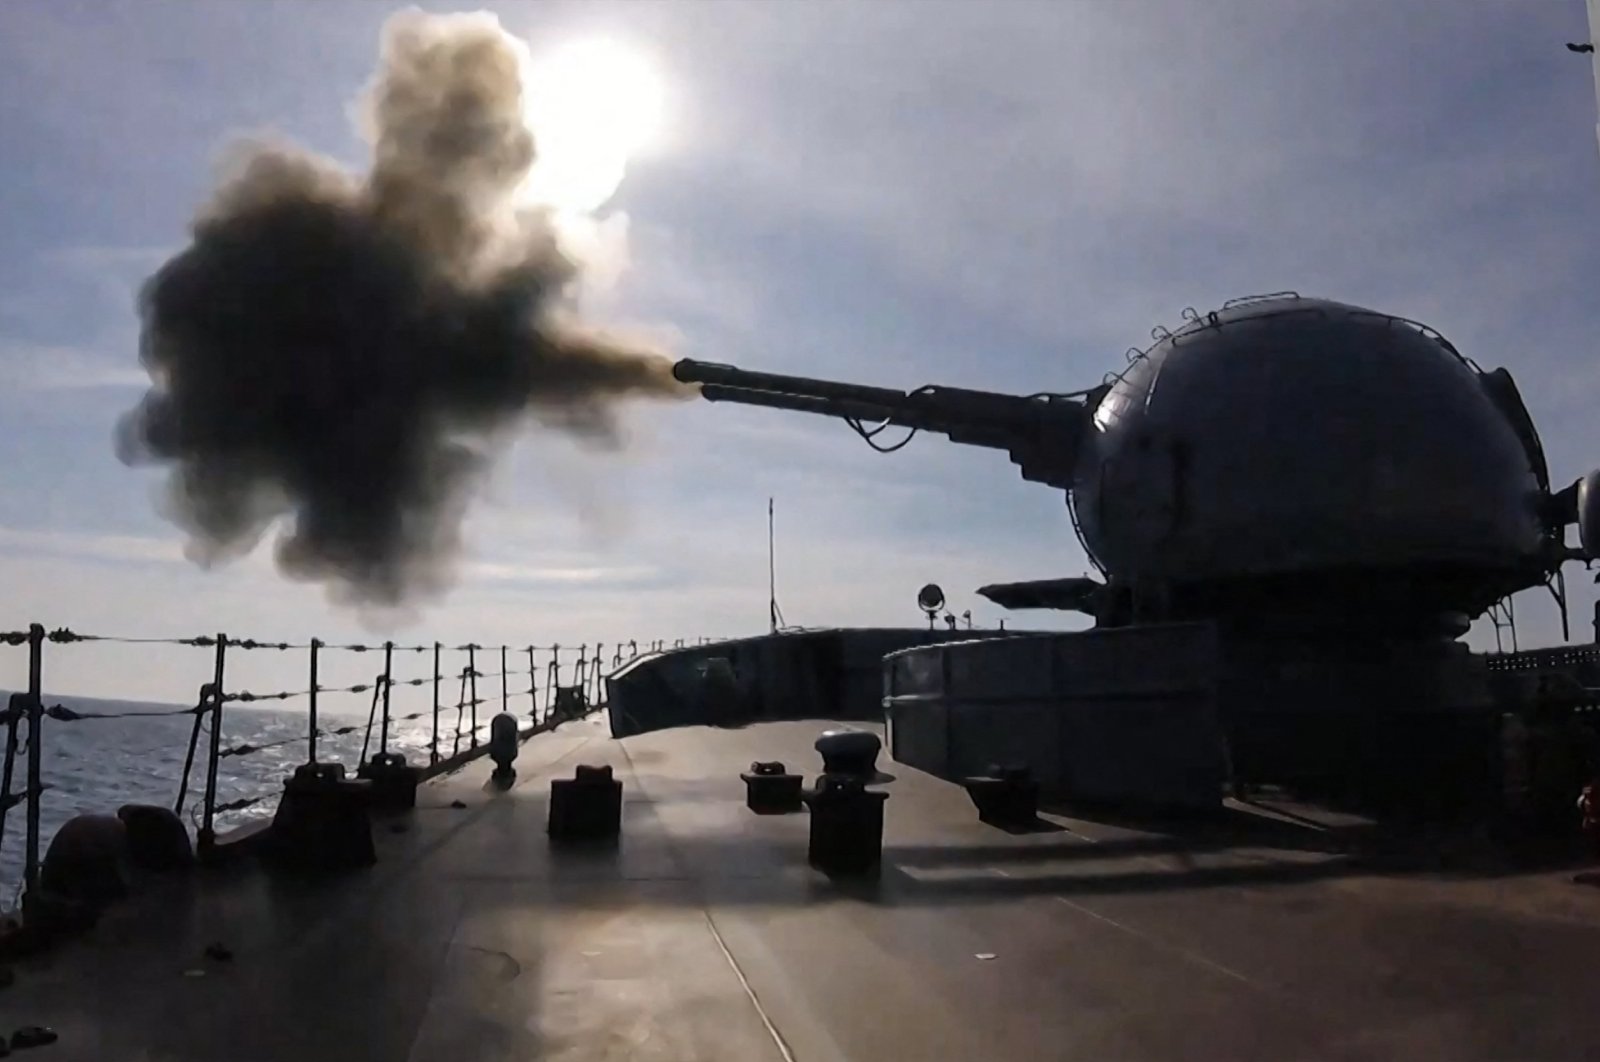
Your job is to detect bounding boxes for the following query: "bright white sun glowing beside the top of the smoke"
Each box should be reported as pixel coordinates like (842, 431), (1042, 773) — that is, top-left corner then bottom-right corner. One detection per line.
(518, 38), (662, 214)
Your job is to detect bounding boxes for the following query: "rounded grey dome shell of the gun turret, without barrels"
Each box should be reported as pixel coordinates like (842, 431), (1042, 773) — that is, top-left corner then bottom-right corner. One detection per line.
(1075, 297), (1541, 581)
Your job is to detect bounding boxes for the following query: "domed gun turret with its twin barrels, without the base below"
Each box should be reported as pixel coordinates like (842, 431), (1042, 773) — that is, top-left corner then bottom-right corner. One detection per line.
(674, 293), (1600, 635)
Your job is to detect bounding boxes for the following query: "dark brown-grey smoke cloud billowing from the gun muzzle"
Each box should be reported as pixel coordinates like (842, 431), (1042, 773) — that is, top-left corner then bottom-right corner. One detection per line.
(118, 11), (677, 606)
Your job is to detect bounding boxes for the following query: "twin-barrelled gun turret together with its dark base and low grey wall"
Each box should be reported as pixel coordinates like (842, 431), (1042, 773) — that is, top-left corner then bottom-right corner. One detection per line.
(674, 293), (1600, 809)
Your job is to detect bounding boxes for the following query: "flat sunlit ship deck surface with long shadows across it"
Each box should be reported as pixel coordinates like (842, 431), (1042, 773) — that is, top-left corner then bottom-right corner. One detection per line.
(0, 720), (1600, 1062)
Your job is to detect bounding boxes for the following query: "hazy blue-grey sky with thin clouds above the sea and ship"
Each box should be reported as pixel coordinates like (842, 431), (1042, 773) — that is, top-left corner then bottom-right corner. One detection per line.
(0, 0), (1600, 699)
